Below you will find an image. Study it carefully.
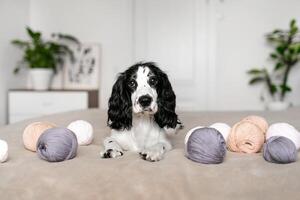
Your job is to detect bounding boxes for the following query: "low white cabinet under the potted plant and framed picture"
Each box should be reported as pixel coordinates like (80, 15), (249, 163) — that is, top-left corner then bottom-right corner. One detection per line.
(8, 90), (98, 123)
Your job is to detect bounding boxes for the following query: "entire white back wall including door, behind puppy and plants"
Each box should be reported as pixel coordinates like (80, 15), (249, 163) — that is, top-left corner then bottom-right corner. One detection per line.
(0, 0), (300, 124)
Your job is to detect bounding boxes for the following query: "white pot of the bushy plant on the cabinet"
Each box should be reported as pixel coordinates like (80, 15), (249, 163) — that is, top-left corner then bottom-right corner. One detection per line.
(29, 68), (53, 90)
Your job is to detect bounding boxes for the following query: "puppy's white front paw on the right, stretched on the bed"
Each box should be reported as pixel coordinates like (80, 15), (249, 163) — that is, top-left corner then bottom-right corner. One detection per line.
(140, 142), (172, 162)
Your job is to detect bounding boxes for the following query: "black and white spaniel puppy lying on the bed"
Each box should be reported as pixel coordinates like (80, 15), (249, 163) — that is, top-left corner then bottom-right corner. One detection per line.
(100, 62), (181, 161)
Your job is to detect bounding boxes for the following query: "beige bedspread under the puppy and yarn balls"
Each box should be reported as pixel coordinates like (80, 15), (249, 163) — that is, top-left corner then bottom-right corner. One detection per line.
(0, 109), (300, 200)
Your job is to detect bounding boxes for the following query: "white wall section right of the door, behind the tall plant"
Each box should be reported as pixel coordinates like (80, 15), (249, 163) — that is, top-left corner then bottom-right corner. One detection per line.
(212, 0), (300, 110)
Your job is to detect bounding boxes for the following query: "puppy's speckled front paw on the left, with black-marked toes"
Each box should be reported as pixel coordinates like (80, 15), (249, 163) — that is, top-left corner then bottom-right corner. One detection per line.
(100, 137), (124, 158)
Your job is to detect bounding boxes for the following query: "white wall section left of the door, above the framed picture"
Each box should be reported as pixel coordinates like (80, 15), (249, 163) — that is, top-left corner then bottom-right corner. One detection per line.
(30, 0), (133, 107)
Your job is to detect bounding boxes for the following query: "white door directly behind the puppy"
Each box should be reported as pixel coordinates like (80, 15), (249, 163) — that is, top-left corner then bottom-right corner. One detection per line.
(133, 0), (210, 110)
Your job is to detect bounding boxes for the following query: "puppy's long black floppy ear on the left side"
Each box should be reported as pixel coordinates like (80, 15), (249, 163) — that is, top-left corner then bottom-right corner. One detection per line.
(107, 73), (132, 130)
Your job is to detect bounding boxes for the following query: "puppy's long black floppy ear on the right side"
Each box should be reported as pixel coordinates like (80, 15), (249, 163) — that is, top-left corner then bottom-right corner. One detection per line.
(154, 69), (178, 128)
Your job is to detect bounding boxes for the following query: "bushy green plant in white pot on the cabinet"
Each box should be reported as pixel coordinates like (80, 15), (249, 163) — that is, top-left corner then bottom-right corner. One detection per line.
(12, 27), (80, 90)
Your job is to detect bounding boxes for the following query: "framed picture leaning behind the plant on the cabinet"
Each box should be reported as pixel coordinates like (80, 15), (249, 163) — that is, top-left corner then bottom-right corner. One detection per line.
(63, 43), (100, 90)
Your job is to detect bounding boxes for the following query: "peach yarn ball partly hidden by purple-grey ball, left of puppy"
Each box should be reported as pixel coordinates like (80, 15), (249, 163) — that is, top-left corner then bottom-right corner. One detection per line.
(23, 122), (55, 151)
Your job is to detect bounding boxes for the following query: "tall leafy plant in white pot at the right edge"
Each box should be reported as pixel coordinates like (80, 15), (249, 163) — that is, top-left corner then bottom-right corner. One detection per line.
(248, 19), (300, 110)
